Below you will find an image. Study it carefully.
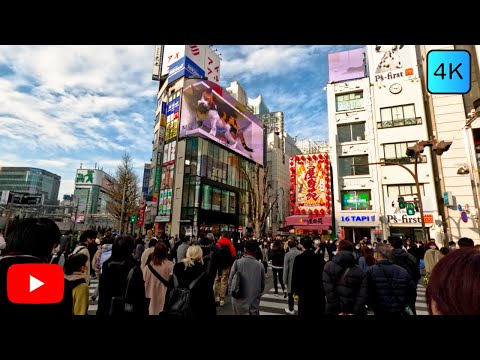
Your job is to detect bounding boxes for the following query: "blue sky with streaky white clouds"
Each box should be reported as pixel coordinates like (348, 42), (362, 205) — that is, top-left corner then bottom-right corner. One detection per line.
(0, 45), (361, 198)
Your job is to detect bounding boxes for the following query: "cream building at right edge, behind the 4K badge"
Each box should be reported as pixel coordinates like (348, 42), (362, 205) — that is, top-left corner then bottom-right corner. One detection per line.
(418, 45), (480, 244)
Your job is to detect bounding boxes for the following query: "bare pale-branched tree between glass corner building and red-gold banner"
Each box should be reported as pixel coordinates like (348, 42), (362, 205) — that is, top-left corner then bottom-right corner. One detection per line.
(242, 164), (278, 239)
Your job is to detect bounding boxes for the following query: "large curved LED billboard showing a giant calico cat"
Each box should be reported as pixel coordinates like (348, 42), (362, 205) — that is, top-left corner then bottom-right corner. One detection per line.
(179, 79), (263, 165)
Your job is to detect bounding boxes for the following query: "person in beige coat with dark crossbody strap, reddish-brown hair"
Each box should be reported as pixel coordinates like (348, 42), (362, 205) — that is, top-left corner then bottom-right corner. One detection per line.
(142, 241), (173, 315)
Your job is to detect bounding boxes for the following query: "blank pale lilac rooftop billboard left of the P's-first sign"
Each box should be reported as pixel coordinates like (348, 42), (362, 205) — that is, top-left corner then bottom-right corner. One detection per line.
(328, 49), (366, 82)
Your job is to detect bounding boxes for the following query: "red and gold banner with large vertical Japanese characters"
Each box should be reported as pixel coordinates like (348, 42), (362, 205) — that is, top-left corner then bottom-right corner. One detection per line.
(290, 153), (332, 215)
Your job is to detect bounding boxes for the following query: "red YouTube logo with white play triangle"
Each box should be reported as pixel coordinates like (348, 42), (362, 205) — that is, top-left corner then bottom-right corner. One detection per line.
(7, 264), (64, 304)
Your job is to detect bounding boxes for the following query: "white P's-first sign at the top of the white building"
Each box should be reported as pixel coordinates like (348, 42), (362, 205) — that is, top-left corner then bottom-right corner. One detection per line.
(368, 45), (418, 82)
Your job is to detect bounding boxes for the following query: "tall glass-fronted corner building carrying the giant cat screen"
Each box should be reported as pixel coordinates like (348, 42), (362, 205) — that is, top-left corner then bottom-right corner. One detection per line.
(149, 45), (264, 236)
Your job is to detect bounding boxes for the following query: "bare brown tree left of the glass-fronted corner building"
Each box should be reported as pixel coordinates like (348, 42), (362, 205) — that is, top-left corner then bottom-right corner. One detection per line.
(107, 153), (140, 230)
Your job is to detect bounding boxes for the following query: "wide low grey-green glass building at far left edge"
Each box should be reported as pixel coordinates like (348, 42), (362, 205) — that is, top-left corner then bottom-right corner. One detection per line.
(0, 167), (61, 205)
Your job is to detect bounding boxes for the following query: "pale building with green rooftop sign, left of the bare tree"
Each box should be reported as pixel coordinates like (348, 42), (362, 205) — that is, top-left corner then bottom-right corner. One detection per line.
(72, 168), (115, 227)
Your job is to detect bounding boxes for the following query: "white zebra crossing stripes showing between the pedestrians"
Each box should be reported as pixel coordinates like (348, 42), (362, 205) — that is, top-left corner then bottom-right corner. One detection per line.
(260, 284), (428, 315)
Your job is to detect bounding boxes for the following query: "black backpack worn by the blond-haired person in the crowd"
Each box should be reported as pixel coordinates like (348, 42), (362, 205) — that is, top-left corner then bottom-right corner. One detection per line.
(162, 272), (205, 318)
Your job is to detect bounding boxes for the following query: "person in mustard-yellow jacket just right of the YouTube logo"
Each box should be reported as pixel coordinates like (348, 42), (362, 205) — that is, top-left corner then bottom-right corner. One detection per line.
(64, 253), (89, 315)
